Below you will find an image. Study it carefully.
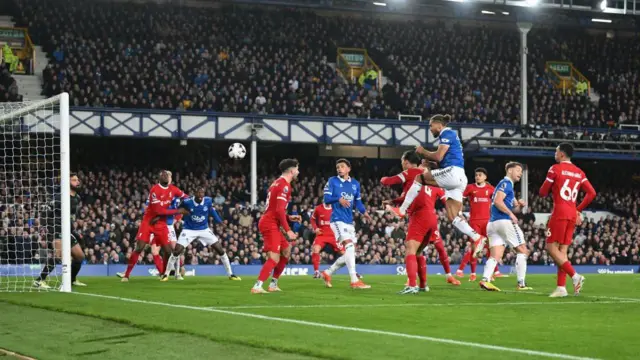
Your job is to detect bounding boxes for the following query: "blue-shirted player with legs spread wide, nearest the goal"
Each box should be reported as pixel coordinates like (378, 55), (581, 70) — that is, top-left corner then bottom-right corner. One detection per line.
(163, 187), (240, 281)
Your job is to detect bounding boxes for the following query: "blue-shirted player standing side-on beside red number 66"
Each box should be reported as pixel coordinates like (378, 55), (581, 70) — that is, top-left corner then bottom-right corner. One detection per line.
(480, 162), (531, 291)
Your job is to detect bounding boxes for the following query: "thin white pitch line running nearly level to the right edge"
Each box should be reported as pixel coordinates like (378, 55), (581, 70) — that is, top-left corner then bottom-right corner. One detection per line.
(207, 300), (638, 310)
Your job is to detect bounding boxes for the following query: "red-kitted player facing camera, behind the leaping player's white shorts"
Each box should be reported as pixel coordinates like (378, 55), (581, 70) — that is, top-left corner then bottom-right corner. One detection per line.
(456, 168), (502, 281)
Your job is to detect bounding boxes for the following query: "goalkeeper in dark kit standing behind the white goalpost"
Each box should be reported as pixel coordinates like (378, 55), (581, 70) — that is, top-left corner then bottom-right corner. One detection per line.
(33, 173), (87, 289)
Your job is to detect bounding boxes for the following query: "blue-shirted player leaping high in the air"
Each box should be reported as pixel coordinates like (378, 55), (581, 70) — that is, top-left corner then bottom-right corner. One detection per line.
(391, 115), (486, 257)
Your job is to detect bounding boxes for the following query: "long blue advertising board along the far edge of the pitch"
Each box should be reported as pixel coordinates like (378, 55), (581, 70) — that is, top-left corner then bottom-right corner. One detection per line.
(0, 264), (639, 277)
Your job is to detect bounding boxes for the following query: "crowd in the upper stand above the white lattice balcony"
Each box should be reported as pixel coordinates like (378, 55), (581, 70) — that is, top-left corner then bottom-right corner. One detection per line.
(3, 0), (640, 127)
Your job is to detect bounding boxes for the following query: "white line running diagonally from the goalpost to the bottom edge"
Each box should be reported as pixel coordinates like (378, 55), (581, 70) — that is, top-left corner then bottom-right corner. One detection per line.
(72, 292), (599, 360)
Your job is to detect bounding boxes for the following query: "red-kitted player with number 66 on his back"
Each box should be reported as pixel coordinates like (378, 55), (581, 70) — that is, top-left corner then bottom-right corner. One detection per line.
(540, 143), (596, 297)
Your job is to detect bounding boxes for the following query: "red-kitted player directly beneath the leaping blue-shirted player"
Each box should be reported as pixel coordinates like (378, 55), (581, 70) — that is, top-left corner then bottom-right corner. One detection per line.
(380, 151), (460, 294)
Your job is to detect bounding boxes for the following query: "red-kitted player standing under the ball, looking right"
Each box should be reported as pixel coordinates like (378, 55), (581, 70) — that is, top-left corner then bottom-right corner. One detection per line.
(251, 159), (300, 294)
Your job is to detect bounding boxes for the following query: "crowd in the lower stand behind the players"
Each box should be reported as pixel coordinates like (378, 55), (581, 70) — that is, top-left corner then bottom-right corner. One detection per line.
(0, 141), (640, 265)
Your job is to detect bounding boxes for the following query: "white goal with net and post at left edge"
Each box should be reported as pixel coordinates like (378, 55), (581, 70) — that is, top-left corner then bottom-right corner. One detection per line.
(0, 93), (71, 292)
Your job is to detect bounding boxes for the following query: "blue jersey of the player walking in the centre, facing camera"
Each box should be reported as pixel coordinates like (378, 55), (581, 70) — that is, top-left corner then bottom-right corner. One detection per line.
(324, 176), (366, 224)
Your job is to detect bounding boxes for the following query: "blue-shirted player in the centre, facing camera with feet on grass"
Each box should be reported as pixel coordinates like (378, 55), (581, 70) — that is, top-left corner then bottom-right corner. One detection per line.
(321, 159), (371, 289)
